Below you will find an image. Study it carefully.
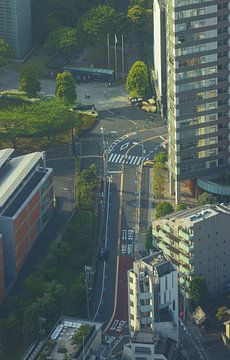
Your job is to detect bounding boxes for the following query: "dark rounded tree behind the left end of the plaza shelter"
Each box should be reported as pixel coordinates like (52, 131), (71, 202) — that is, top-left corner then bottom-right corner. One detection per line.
(45, 26), (83, 62)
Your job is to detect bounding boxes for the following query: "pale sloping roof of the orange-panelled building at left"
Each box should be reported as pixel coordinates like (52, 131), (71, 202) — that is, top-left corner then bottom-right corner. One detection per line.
(0, 152), (43, 208)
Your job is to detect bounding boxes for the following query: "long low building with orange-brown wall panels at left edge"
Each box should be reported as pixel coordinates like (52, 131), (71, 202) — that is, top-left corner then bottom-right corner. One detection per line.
(0, 149), (53, 298)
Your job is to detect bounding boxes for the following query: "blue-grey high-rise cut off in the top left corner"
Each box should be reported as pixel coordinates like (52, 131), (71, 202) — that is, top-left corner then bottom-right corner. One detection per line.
(0, 0), (32, 58)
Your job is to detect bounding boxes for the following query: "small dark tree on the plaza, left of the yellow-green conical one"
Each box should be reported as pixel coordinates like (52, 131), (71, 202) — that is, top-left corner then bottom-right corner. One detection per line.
(19, 67), (41, 98)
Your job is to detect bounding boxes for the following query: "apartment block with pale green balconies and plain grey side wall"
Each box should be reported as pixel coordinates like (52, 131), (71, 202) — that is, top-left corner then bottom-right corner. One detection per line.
(153, 205), (230, 297)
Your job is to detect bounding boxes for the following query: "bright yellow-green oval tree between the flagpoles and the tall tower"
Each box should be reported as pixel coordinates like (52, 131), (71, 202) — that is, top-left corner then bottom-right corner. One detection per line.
(126, 61), (150, 97)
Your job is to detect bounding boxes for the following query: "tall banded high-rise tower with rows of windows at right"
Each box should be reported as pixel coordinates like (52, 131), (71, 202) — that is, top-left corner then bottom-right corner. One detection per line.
(155, 0), (230, 202)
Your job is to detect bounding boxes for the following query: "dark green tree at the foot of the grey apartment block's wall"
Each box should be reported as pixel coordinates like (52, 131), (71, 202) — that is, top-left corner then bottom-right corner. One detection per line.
(189, 276), (208, 305)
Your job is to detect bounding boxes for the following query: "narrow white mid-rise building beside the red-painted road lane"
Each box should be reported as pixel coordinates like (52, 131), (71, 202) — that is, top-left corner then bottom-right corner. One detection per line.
(128, 251), (178, 339)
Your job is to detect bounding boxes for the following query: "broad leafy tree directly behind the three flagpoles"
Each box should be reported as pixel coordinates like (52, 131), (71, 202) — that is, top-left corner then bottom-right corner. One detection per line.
(83, 5), (126, 45)
